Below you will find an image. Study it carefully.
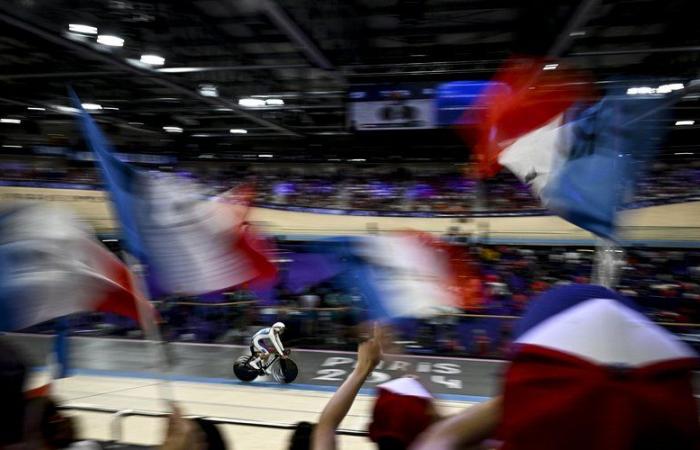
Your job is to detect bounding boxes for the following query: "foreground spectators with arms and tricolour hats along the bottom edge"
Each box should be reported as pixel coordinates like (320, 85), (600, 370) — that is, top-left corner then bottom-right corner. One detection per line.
(0, 284), (700, 450)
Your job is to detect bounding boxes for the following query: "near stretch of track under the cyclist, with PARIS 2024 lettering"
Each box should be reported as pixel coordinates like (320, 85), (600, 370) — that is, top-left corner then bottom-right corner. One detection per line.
(6, 334), (700, 450)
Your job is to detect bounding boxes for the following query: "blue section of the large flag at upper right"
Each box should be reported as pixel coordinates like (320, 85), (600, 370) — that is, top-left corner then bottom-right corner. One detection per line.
(541, 95), (668, 239)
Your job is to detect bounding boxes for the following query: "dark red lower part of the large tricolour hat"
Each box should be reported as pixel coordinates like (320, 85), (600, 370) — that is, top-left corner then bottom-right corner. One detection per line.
(499, 346), (700, 450)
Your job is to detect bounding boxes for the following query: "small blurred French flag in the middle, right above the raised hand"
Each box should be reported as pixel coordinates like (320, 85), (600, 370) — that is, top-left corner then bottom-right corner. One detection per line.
(319, 232), (478, 319)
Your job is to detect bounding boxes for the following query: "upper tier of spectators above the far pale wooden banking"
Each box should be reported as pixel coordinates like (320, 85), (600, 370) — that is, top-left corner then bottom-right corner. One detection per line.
(0, 158), (700, 213)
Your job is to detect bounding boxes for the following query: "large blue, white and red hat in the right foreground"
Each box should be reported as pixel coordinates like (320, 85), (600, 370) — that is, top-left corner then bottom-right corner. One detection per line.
(500, 285), (700, 450)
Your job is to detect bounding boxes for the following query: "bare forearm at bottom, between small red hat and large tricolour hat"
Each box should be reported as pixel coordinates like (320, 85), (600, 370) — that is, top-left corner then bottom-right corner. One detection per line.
(411, 397), (503, 450)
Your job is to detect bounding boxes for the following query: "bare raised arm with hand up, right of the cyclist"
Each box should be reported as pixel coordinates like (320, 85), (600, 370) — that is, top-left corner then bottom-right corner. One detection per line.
(311, 325), (382, 450)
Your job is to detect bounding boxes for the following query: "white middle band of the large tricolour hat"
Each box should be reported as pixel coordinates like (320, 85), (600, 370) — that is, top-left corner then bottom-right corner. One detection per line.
(517, 299), (696, 366)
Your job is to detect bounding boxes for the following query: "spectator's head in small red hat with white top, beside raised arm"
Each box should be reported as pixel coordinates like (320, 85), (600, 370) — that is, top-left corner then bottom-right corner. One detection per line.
(369, 377), (438, 450)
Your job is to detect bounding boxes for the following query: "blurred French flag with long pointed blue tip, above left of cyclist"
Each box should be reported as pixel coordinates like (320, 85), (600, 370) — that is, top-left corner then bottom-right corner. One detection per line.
(71, 93), (276, 295)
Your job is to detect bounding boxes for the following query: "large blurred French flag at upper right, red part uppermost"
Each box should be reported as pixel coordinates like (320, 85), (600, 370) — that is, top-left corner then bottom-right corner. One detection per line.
(465, 61), (666, 238)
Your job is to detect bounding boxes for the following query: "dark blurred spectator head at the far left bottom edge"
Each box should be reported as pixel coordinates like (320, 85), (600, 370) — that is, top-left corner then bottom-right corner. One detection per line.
(0, 338), (27, 448)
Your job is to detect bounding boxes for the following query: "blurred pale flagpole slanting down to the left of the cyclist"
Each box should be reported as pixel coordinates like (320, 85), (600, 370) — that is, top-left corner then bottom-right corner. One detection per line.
(122, 250), (175, 407)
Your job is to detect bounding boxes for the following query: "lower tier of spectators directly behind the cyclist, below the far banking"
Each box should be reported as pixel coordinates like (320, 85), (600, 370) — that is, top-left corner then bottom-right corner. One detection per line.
(40, 245), (700, 358)
